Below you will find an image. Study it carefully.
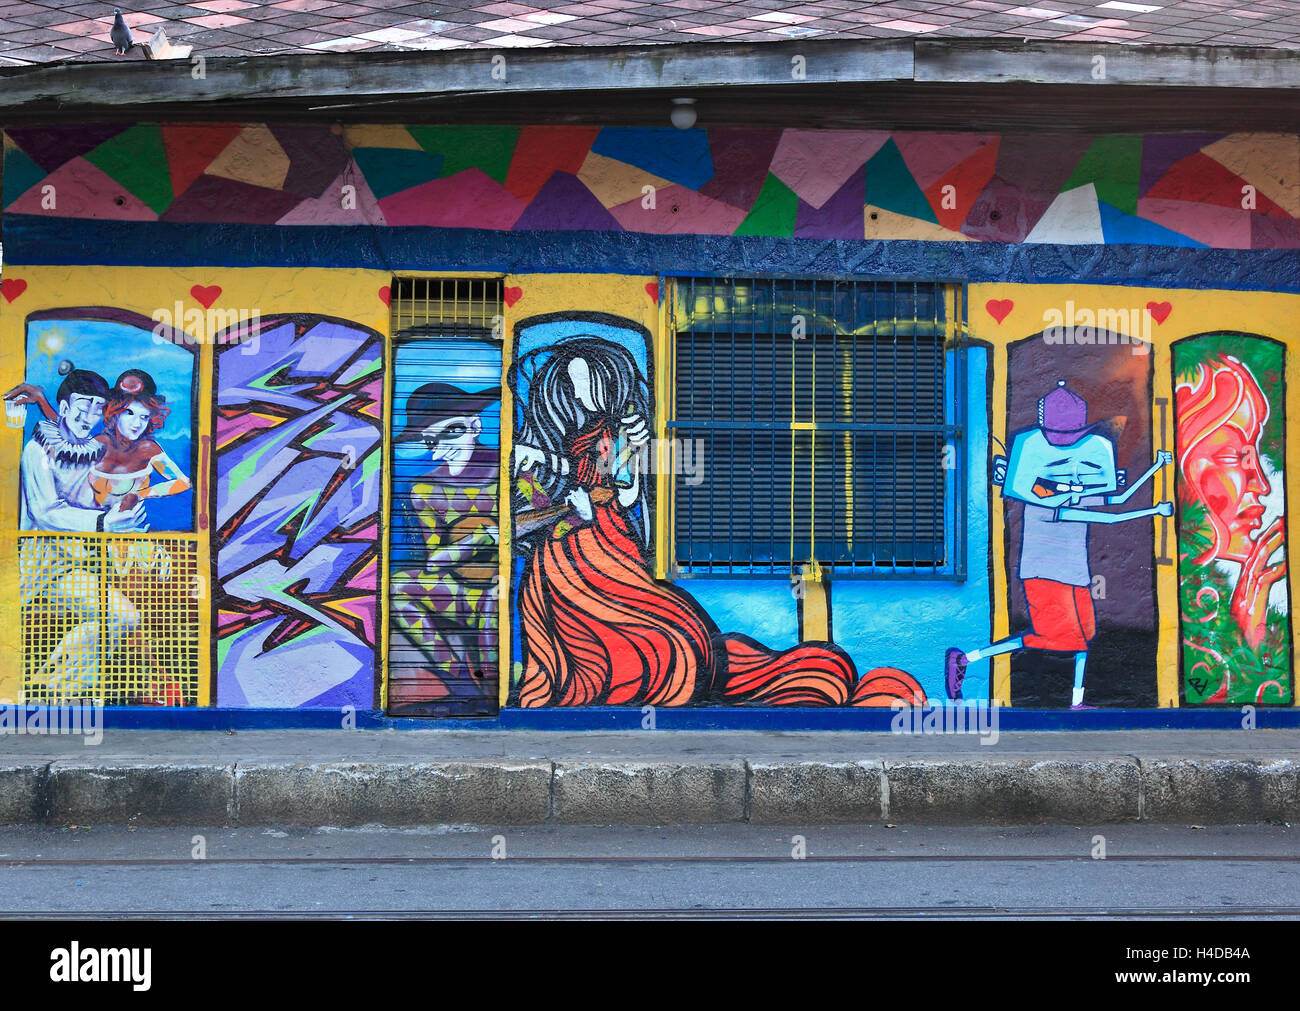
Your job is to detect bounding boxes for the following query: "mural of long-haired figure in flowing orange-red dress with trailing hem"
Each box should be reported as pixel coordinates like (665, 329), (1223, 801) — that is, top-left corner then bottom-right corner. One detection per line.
(511, 313), (924, 707)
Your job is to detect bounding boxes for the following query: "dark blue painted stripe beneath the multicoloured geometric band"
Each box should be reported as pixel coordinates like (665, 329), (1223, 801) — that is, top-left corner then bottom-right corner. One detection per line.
(3, 214), (1300, 291)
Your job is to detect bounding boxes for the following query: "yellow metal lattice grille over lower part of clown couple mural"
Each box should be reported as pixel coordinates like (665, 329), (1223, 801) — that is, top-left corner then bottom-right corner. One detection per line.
(18, 533), (200, 706)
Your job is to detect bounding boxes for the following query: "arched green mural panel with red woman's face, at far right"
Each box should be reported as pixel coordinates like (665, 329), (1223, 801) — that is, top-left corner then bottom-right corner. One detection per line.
(1174, 334), (1292, 704)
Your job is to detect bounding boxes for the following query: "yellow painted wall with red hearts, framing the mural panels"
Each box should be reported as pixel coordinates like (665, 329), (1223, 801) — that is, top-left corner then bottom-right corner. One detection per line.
(0, 266), (1300, 706)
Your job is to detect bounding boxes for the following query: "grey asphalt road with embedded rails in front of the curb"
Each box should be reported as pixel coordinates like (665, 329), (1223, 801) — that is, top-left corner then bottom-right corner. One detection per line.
(0, 825), (1300, 919)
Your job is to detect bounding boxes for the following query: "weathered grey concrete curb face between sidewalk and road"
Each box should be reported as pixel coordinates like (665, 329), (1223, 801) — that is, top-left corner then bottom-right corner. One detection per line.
(0, 758), (1300, 826)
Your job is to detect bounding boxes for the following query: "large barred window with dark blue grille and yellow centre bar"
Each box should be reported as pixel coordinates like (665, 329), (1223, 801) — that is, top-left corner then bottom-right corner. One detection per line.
(667, 277), (965, 578)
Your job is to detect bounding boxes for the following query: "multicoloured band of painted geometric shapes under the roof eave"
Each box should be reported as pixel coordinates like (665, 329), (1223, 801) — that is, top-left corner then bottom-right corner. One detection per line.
(0, 123), (1300, 250)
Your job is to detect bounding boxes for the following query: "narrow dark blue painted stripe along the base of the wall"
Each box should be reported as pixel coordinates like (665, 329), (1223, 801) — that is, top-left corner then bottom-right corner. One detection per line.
(38, 706), (1300, 733)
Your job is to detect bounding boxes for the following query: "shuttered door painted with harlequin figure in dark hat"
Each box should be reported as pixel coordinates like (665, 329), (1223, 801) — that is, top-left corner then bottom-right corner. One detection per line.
(389, 333), (501, 716)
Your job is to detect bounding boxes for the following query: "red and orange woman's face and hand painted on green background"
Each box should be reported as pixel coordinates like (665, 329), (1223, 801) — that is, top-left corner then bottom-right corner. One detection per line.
(1174, 355), (1287, 648)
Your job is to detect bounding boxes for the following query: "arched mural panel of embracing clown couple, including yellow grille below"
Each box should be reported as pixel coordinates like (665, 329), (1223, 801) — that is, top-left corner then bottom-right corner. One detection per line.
(5, 309), (198, 706)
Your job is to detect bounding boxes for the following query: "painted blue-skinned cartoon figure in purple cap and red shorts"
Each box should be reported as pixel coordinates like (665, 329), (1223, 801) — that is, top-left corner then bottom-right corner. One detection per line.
(944, 379), (1174, 710)
